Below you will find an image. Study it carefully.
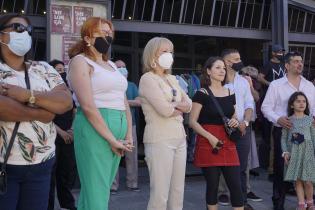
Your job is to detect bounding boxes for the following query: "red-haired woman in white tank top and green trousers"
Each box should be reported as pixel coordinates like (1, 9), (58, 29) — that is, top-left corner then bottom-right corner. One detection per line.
(68, 17), (133, 210)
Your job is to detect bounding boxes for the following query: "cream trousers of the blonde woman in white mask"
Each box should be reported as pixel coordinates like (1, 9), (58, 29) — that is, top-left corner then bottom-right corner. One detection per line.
(144, 138), (186, 210)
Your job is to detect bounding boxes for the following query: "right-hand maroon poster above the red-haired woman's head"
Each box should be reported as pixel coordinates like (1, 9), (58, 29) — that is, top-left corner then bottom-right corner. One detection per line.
(73, 6), (93, 34)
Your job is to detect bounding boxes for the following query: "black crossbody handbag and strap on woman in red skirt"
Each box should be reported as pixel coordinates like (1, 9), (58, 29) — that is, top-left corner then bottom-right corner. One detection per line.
(206, 87), (241, 142)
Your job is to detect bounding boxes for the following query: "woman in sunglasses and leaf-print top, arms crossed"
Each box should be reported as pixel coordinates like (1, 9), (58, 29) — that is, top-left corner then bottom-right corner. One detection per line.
(0, 14), (72, 210)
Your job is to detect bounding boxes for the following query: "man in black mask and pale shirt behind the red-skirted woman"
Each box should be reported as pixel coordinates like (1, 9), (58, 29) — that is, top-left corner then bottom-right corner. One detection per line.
(219, 49), (254, 210)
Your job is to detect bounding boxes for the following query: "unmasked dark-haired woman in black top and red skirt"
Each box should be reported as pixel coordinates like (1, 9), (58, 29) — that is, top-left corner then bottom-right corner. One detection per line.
(189, 57), (244, 210)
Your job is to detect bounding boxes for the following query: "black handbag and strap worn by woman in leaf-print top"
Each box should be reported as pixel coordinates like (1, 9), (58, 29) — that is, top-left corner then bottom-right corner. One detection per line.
(0, 67), (30, 195)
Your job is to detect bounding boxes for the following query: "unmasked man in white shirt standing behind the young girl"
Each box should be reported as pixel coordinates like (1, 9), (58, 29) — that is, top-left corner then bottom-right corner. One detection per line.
(261, 52), (315, 210)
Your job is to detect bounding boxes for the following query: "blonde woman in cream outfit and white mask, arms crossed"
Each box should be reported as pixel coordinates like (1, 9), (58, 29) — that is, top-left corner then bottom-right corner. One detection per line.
(139, 37), (191, 210)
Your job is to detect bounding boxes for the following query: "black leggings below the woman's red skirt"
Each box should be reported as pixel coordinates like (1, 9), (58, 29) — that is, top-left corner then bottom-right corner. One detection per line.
(201, 166), (244, 207)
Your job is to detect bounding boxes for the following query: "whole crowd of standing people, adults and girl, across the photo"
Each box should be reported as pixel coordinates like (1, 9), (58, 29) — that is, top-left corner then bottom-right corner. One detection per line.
(0, 15), (315, 210)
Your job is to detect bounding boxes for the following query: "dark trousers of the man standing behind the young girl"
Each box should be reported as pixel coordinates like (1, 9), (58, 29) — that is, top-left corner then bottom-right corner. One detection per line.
(272, 126), (288, 210)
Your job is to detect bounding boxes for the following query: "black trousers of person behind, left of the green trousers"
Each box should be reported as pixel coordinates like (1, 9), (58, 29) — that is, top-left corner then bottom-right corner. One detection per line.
(48, 141), (77, 210)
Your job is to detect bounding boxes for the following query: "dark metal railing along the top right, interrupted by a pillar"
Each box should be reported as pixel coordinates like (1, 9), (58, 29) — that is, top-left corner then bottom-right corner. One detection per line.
(111, 0), (315, 33)
